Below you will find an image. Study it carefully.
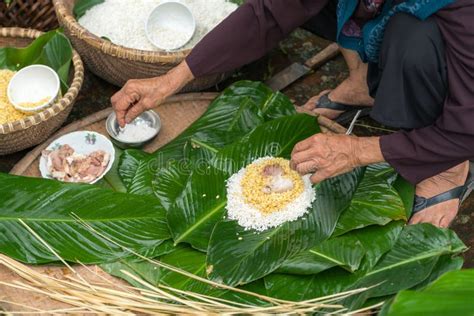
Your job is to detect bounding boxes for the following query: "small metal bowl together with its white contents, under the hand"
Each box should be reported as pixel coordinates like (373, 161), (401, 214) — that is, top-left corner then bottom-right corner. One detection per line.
(105, 110), (161, 149)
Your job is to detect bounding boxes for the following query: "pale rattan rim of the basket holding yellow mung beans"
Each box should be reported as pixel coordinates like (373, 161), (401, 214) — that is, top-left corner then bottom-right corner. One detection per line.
(0, 27), (84, 134)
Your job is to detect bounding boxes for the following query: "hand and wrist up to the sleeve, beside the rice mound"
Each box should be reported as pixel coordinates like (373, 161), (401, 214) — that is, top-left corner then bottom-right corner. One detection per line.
(290, 134), (383, 183)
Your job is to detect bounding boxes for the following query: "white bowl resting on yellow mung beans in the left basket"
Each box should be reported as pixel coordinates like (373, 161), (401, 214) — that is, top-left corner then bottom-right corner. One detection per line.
(7, 65), (60, 112)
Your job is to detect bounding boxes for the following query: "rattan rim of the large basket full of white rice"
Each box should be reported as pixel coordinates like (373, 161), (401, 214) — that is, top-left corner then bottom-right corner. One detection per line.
(53, 0), (191, 63)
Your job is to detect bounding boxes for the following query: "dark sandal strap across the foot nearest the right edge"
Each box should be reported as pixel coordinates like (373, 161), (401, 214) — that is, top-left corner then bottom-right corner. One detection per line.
(411, 162), (474, 217)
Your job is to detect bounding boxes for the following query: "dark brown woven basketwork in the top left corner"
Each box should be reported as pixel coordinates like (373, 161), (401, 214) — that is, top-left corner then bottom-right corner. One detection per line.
(0, 0), (58, 31)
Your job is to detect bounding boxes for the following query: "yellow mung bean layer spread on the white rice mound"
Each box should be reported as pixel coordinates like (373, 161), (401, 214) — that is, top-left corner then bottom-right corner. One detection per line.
(241, 158), (304, 214)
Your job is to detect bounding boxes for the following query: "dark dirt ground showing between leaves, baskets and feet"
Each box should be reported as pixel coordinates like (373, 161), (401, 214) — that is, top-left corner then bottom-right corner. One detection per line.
(0, 30), (474, 268)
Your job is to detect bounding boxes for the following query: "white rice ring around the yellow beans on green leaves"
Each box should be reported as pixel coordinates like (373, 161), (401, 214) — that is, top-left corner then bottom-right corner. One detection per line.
(226, 157), (316, 231)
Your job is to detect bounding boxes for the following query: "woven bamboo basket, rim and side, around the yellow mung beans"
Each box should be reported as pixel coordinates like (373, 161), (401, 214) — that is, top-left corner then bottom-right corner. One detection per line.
(0, 28), (84, 155)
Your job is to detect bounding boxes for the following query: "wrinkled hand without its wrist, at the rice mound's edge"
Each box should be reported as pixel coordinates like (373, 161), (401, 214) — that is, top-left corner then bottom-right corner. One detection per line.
(291, 134), (360, 183)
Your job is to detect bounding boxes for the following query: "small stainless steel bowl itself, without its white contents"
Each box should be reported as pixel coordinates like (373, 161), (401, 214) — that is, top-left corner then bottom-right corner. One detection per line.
(105, 110), (161, 149)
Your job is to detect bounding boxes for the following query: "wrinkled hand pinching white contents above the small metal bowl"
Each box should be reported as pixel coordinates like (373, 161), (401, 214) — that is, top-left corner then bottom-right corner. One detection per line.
(110, 77), (172, 127)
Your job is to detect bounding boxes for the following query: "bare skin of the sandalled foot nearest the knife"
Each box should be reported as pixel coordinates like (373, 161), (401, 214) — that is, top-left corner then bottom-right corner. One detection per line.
(303, 67), (374, 120)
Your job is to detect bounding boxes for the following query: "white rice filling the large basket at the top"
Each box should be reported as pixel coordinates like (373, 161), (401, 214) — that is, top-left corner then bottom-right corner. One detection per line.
(79, 0), (241, 50)
